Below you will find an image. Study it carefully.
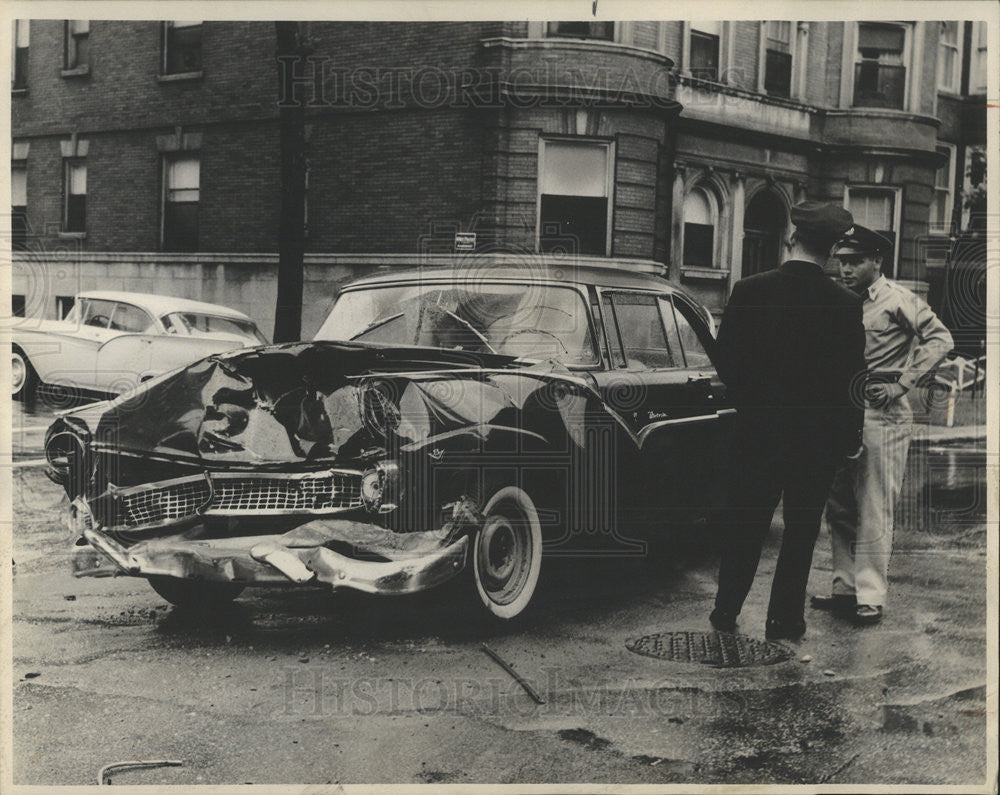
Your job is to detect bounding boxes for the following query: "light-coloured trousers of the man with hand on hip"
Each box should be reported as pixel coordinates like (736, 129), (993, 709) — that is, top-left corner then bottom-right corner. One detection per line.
(826, 395), (913, 605)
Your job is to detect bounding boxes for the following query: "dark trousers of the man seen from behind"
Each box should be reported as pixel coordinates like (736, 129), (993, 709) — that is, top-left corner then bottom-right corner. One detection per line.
(715, 438), (836, 623)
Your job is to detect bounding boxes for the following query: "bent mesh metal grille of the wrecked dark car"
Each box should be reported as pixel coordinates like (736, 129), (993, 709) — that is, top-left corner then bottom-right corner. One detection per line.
(118, 470), (362, 527)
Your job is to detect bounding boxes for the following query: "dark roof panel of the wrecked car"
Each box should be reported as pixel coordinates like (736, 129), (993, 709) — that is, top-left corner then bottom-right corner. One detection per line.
(344, 260), (683, 293)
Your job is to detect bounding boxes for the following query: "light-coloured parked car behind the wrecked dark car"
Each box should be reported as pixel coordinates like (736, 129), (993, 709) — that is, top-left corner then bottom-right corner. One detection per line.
(11, 290), (267, 400)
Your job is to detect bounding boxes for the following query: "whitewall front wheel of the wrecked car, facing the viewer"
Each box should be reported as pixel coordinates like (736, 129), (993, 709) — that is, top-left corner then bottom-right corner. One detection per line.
(470, 486), (542, 620)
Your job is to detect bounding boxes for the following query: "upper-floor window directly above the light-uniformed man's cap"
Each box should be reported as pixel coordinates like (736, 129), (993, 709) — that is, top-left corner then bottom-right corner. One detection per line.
(854, 22), (906, 110)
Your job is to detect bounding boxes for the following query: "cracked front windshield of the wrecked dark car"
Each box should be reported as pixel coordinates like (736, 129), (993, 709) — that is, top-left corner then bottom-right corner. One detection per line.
(316, 283), (598, 365)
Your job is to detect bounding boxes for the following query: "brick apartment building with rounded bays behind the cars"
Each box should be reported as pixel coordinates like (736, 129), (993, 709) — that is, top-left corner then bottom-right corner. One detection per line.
(11, 20), (986, 336)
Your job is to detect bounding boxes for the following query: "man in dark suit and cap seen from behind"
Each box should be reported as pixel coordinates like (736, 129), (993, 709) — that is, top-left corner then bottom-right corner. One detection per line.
(710, 202), (865, 639)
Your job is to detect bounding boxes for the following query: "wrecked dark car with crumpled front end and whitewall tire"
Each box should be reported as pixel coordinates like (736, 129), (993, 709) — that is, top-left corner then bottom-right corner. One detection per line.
(46, 266), (734, 619)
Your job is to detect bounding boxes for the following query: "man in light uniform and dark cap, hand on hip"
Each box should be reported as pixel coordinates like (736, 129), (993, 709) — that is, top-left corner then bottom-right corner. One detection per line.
(811, 225), (953, 626)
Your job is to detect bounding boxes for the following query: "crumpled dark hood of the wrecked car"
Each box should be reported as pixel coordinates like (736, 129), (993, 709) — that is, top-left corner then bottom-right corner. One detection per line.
(57, 342), (608, 481)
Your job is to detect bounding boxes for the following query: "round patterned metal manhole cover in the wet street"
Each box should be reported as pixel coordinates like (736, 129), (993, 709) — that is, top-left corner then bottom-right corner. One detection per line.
(625, 632), (792, 668)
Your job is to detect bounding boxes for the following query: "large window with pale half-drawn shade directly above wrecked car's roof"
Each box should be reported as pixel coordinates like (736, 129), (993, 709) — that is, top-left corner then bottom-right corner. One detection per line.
(538, 139), (612, 257)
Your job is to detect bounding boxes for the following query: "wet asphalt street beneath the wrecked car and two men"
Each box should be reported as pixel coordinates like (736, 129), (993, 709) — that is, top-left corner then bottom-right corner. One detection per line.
(7, 406), (996, 792)
